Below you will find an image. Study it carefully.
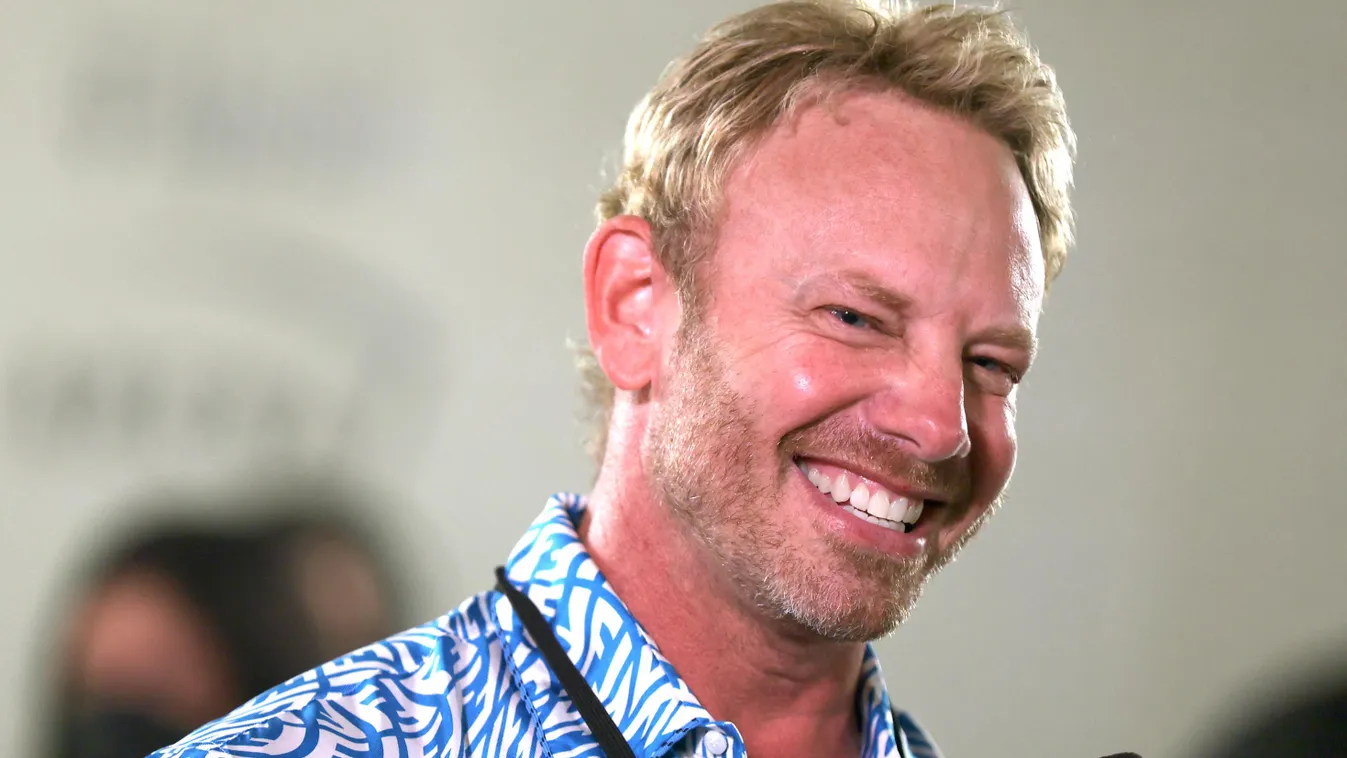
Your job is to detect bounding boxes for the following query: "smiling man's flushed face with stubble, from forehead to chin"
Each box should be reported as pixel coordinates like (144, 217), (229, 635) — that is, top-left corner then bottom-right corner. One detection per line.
(643, 94), (1044, 640)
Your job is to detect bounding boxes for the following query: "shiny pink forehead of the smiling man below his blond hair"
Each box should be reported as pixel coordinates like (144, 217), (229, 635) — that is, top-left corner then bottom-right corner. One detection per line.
(715, 93), (1044, 326)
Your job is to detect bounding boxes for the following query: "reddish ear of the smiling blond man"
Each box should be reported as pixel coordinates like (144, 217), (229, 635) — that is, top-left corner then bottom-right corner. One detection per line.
(585, 215), (664, 392)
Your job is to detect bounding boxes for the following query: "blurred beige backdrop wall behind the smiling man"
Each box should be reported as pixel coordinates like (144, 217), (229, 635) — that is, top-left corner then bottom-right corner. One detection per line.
(0, 0), (1347, 757)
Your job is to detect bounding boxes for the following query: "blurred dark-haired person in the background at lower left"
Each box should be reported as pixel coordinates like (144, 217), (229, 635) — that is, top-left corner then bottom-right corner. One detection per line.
(46, 494), (404, 758)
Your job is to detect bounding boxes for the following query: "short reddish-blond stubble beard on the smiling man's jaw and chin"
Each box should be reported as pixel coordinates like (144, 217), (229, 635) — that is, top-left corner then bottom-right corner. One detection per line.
(643, 322), (991, 642)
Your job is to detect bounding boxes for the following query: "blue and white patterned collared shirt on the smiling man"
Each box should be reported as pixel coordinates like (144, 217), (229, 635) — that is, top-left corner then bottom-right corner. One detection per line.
(151, 494), (939, 758)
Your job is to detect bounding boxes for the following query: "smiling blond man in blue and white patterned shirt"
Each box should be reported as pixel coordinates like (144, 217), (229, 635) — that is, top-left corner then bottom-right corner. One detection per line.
(150, 1), (1072, 758)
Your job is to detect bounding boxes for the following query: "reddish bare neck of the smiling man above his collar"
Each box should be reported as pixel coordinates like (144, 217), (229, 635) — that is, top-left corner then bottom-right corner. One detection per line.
(581, 446), (865, 757)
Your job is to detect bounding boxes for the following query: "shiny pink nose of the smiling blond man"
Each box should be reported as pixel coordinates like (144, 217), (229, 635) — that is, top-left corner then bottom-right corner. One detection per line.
(865, 355), (973, 463)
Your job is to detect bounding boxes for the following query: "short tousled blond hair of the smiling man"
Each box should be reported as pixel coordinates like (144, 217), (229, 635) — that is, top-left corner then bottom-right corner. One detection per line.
(578, 0), (1075, 463)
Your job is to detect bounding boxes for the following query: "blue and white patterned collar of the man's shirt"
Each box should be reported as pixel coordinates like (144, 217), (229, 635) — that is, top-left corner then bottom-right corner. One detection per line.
(494, 494), (900, 758)
